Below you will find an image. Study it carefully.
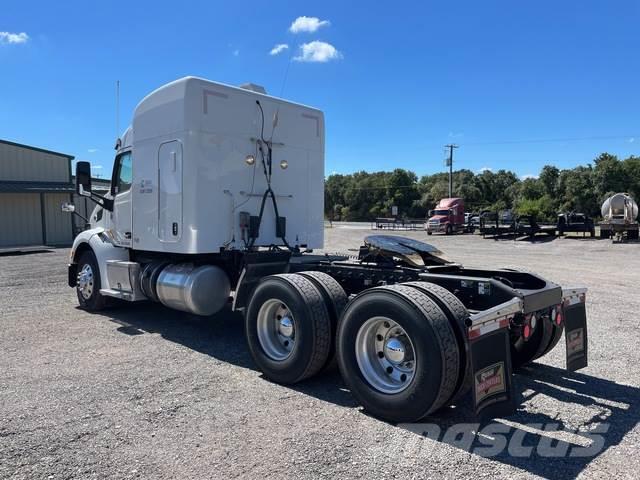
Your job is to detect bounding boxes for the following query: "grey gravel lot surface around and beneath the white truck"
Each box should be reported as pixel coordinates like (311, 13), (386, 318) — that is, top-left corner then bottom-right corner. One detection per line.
(0, 230), (640, 479)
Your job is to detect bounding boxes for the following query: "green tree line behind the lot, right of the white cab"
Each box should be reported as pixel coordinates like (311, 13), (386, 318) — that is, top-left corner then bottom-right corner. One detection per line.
(325, 153), (640, 221)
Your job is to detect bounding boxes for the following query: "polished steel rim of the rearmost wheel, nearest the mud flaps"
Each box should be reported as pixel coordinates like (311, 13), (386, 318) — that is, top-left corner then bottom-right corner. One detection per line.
(355, 317), (416, 394)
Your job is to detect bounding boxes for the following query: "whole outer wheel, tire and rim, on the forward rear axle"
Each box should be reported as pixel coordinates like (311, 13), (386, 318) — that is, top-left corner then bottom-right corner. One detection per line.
(245, 274), (331, 384)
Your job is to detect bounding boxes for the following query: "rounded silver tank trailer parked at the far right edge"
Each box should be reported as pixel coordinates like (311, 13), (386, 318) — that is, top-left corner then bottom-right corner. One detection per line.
(600, 193), (638, 241)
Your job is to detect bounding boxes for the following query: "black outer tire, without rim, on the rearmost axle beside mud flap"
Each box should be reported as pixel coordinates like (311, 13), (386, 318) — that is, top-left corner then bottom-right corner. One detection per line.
(336, 285), (460, 422)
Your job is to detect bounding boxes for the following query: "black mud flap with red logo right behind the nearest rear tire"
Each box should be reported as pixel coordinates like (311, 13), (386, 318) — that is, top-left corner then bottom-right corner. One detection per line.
(468, 298), (522, 419)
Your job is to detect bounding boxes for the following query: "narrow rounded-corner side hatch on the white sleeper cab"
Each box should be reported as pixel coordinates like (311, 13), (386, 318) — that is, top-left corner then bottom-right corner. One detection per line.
(158, 141), (182, 242)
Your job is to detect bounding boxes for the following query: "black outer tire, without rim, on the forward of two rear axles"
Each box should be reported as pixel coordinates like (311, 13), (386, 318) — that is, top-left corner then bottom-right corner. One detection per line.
(245, 274), (331, 384)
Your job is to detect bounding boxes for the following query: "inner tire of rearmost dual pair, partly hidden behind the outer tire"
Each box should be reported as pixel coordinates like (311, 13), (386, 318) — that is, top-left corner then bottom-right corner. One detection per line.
(402, 282), (473, 403)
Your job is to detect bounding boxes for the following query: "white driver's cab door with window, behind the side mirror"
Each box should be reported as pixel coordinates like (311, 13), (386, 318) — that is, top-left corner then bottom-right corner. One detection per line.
(111, 152), (133, 247)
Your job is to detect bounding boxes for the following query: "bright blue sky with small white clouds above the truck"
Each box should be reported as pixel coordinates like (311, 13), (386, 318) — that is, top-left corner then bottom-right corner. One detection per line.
(0, 0), (640, 177)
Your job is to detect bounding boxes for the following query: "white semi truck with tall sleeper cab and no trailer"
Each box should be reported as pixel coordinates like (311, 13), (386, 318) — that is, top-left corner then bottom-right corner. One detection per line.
(68, 77), (587, 421)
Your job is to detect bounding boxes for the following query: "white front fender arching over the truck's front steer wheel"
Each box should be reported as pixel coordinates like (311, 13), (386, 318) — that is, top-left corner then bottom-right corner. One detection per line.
(69, 227), (129, 288)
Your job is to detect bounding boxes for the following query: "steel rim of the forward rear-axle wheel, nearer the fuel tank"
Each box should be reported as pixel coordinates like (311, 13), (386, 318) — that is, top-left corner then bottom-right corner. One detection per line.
(257, 298), (296, 362)
